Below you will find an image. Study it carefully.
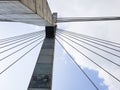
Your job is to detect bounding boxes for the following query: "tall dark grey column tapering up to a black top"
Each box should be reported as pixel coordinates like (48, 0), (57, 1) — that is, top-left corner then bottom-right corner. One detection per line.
(28, 26), (56, 90)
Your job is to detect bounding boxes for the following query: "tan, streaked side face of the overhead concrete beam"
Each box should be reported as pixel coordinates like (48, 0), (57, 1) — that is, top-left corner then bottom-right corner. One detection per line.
(20, 0), (55, 25)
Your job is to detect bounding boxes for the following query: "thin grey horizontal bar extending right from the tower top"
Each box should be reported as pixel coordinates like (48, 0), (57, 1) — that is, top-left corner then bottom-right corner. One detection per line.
(57, 16), (120, 23)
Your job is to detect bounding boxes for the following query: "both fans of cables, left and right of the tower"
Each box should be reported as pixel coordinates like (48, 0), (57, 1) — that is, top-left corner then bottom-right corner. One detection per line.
(0, 29), (120, 90)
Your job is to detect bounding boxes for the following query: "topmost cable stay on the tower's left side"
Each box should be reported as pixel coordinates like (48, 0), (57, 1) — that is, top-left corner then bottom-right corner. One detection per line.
(0, 32), (43, 45)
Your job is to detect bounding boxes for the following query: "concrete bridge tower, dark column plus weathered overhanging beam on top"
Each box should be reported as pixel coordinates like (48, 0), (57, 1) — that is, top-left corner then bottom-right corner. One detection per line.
(0, 0), (56, 90)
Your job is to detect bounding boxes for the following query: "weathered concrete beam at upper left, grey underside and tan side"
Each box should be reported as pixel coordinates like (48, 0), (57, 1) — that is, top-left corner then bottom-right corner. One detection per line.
(0, 0), (55, 26)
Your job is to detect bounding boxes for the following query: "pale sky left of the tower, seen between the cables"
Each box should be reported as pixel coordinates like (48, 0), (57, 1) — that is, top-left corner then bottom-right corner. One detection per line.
(0, 23), (44, 90)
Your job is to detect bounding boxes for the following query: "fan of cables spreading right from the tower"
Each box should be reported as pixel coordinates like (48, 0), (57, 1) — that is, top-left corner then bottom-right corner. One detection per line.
(56, 29), (120, 90)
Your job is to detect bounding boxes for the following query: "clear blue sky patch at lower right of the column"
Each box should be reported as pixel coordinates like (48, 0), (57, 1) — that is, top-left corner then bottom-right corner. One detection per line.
(53, 43), (108, 90)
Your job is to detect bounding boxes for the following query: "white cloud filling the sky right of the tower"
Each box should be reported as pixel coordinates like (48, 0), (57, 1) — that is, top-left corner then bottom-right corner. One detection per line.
(49, 0), (120, 90)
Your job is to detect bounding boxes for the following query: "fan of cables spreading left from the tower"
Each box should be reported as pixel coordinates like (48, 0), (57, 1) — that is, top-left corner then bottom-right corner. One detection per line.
(0, 30), (45, 75)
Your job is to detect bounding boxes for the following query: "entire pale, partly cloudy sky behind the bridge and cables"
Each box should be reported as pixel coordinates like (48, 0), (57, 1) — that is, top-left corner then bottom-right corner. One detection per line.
(0, 0), (120, 90)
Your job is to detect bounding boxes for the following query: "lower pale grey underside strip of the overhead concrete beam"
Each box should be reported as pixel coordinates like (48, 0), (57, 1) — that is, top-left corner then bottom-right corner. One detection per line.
(0, 13), (49, 26)
